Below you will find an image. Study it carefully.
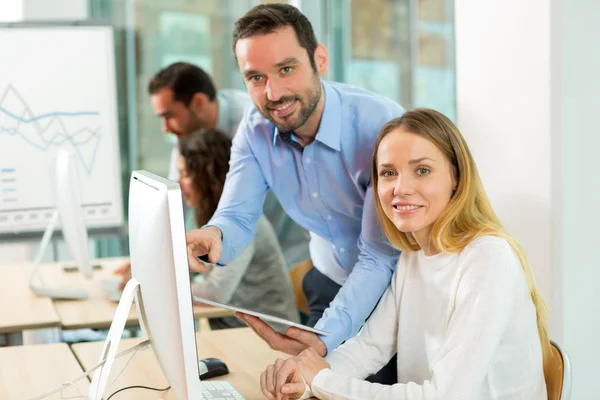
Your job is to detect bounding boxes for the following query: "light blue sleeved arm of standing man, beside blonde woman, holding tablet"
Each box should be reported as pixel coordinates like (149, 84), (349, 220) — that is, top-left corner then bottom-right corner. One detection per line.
(315, 187), (400, 352)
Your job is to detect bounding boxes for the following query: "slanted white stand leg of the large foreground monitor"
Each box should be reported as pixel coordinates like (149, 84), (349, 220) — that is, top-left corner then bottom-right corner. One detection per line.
(86, 278), (141, 400)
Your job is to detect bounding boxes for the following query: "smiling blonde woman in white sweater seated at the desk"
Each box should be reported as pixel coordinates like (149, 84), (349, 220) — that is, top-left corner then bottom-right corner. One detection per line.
(261, 109), (550, 400)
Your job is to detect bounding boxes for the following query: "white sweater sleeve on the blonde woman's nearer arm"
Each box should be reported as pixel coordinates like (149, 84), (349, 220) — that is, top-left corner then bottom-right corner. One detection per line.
(311, 239), (520, 400)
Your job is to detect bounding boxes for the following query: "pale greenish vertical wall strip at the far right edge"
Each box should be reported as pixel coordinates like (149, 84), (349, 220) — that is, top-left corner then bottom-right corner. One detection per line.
(552, 0), (600, 399)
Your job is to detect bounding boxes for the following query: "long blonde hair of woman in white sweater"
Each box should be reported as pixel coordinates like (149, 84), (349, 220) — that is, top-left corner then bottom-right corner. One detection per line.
(371, 108), (551, 372)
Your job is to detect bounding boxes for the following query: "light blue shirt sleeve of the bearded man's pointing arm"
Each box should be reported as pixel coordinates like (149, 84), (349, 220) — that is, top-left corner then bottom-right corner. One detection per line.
(207, 117), (268, 265)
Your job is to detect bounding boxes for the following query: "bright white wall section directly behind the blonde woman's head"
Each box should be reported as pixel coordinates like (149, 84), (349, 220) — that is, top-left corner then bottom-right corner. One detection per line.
(455, 0), (552, 298)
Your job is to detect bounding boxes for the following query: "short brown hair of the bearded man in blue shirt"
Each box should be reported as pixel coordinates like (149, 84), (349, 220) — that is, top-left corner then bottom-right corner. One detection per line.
(233, 4), (319, 72)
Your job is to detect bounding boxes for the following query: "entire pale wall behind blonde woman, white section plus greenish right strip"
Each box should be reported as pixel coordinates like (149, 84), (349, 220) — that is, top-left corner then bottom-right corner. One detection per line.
(455, 0), (600, 399)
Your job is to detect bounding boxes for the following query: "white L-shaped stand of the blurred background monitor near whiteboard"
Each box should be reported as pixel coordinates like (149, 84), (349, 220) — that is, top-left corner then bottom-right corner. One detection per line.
(29, 211), (88, 300)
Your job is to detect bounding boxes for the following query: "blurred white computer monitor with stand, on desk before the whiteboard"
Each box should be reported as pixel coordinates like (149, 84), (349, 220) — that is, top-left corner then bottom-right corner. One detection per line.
(30, 148), (92, 299)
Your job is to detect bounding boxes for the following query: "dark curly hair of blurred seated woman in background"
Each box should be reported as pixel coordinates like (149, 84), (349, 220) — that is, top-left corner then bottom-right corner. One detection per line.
(179, 129), (231, 226)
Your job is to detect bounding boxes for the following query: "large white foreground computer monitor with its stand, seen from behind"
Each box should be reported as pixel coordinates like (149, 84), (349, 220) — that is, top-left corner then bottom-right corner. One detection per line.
(90, 171), (202, 400)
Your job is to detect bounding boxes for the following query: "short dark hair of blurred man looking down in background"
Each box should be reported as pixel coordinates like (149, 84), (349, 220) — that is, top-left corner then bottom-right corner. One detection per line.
(148, 62), (217, 106)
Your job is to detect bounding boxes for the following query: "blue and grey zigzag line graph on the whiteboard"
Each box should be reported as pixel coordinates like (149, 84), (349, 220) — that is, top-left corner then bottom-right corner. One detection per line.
(0, 85), (101, 175)
